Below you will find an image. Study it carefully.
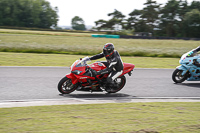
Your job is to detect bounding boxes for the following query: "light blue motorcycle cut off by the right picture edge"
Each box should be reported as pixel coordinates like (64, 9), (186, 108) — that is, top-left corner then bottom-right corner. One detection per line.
(172, 50), (200, 83)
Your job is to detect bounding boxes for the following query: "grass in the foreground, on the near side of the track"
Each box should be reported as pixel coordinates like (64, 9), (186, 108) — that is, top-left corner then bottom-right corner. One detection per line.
(0, 102), (200, 133)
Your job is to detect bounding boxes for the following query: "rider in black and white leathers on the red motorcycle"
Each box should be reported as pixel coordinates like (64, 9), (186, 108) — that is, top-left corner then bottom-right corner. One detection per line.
(90, 43), (124, 91)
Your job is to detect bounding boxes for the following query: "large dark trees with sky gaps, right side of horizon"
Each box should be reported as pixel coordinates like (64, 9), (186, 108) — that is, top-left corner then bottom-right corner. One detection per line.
(95, 0), (200, 38)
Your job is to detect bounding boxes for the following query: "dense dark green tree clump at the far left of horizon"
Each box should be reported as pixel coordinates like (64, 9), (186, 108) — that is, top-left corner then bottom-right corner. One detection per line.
(0, 0), (58, 28)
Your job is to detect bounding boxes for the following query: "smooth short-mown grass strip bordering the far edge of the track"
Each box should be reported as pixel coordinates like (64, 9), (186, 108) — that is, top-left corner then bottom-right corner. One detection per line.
(0, 52), (179, 68)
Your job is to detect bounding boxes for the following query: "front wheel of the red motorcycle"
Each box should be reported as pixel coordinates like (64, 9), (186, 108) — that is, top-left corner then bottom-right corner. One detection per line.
(58, 77), (78, 94)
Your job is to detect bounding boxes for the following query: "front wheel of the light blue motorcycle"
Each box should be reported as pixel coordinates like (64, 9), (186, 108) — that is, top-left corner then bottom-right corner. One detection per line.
(172, 69), (188, 83)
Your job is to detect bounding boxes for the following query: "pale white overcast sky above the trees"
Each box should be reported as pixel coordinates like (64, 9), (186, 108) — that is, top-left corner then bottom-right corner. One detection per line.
(46, 0), (198, 26)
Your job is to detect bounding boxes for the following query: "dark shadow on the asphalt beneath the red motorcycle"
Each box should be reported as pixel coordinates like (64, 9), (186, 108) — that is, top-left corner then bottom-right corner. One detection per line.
(60, 93), (135, 101)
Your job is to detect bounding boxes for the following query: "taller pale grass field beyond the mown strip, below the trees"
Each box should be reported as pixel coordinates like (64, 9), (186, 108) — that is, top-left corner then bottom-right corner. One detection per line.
(0, 29), (200, 57)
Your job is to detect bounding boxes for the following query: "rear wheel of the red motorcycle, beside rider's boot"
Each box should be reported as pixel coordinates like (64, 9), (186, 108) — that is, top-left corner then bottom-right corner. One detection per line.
(105, 75), (126, 93)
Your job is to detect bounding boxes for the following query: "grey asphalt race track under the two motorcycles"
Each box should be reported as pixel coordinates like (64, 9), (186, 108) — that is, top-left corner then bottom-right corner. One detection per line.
(0, 67), (200, 107)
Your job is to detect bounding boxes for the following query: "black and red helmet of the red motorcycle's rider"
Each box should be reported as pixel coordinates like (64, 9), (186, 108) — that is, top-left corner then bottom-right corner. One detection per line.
(103, 43), (115, 58)
